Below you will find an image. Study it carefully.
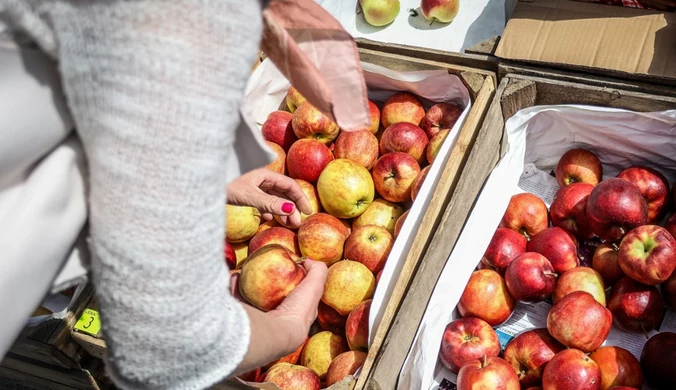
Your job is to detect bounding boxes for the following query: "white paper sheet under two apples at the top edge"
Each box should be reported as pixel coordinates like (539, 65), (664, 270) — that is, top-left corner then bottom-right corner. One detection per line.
(317, 0), (516, 52)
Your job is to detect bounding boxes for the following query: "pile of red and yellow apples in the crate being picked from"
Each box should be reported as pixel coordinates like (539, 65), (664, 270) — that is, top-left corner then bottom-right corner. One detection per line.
(225, 87), (462, 390)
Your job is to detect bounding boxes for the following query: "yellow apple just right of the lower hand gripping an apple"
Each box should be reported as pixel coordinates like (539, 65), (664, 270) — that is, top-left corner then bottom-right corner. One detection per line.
(322, 260), (376, 316)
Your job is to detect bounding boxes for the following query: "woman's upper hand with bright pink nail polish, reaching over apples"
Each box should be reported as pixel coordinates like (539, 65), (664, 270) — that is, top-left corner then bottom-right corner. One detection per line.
(226, 168), (312, 228)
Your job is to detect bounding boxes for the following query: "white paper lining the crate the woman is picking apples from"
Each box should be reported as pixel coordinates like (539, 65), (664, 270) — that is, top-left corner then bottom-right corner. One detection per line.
(243, 60), (471, 386)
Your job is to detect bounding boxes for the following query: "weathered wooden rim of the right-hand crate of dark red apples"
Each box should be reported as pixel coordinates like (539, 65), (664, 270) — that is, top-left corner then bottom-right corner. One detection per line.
(364, 74), (676, 389)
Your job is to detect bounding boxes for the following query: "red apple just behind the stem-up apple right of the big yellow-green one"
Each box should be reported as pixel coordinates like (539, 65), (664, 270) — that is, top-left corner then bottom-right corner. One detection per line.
(380, 122), (429, 164)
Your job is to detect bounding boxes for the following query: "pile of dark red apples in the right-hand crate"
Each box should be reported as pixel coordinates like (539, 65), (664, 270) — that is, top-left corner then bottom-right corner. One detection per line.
(439, 149), (676, 390)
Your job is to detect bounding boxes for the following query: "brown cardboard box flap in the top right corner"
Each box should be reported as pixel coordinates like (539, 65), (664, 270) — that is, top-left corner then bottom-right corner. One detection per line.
(495, 0), (676, 79)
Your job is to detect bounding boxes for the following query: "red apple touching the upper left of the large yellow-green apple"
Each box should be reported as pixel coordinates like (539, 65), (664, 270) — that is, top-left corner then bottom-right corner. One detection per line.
(286, 139), (333, 183)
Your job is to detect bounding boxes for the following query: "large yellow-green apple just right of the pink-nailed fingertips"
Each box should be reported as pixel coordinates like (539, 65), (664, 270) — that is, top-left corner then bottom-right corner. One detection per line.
(317, 158), (375, 218)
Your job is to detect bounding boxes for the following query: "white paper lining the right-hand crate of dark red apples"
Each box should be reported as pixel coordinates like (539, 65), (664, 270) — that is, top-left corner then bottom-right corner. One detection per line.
(399, 105), (676, 389)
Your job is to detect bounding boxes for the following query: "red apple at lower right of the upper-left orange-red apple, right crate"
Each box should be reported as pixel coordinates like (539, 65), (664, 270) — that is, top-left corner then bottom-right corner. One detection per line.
(528, 227), (580, 273)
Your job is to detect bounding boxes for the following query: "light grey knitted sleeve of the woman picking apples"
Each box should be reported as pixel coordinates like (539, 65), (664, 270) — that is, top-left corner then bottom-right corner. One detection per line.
(0, 0), (261, 389)
